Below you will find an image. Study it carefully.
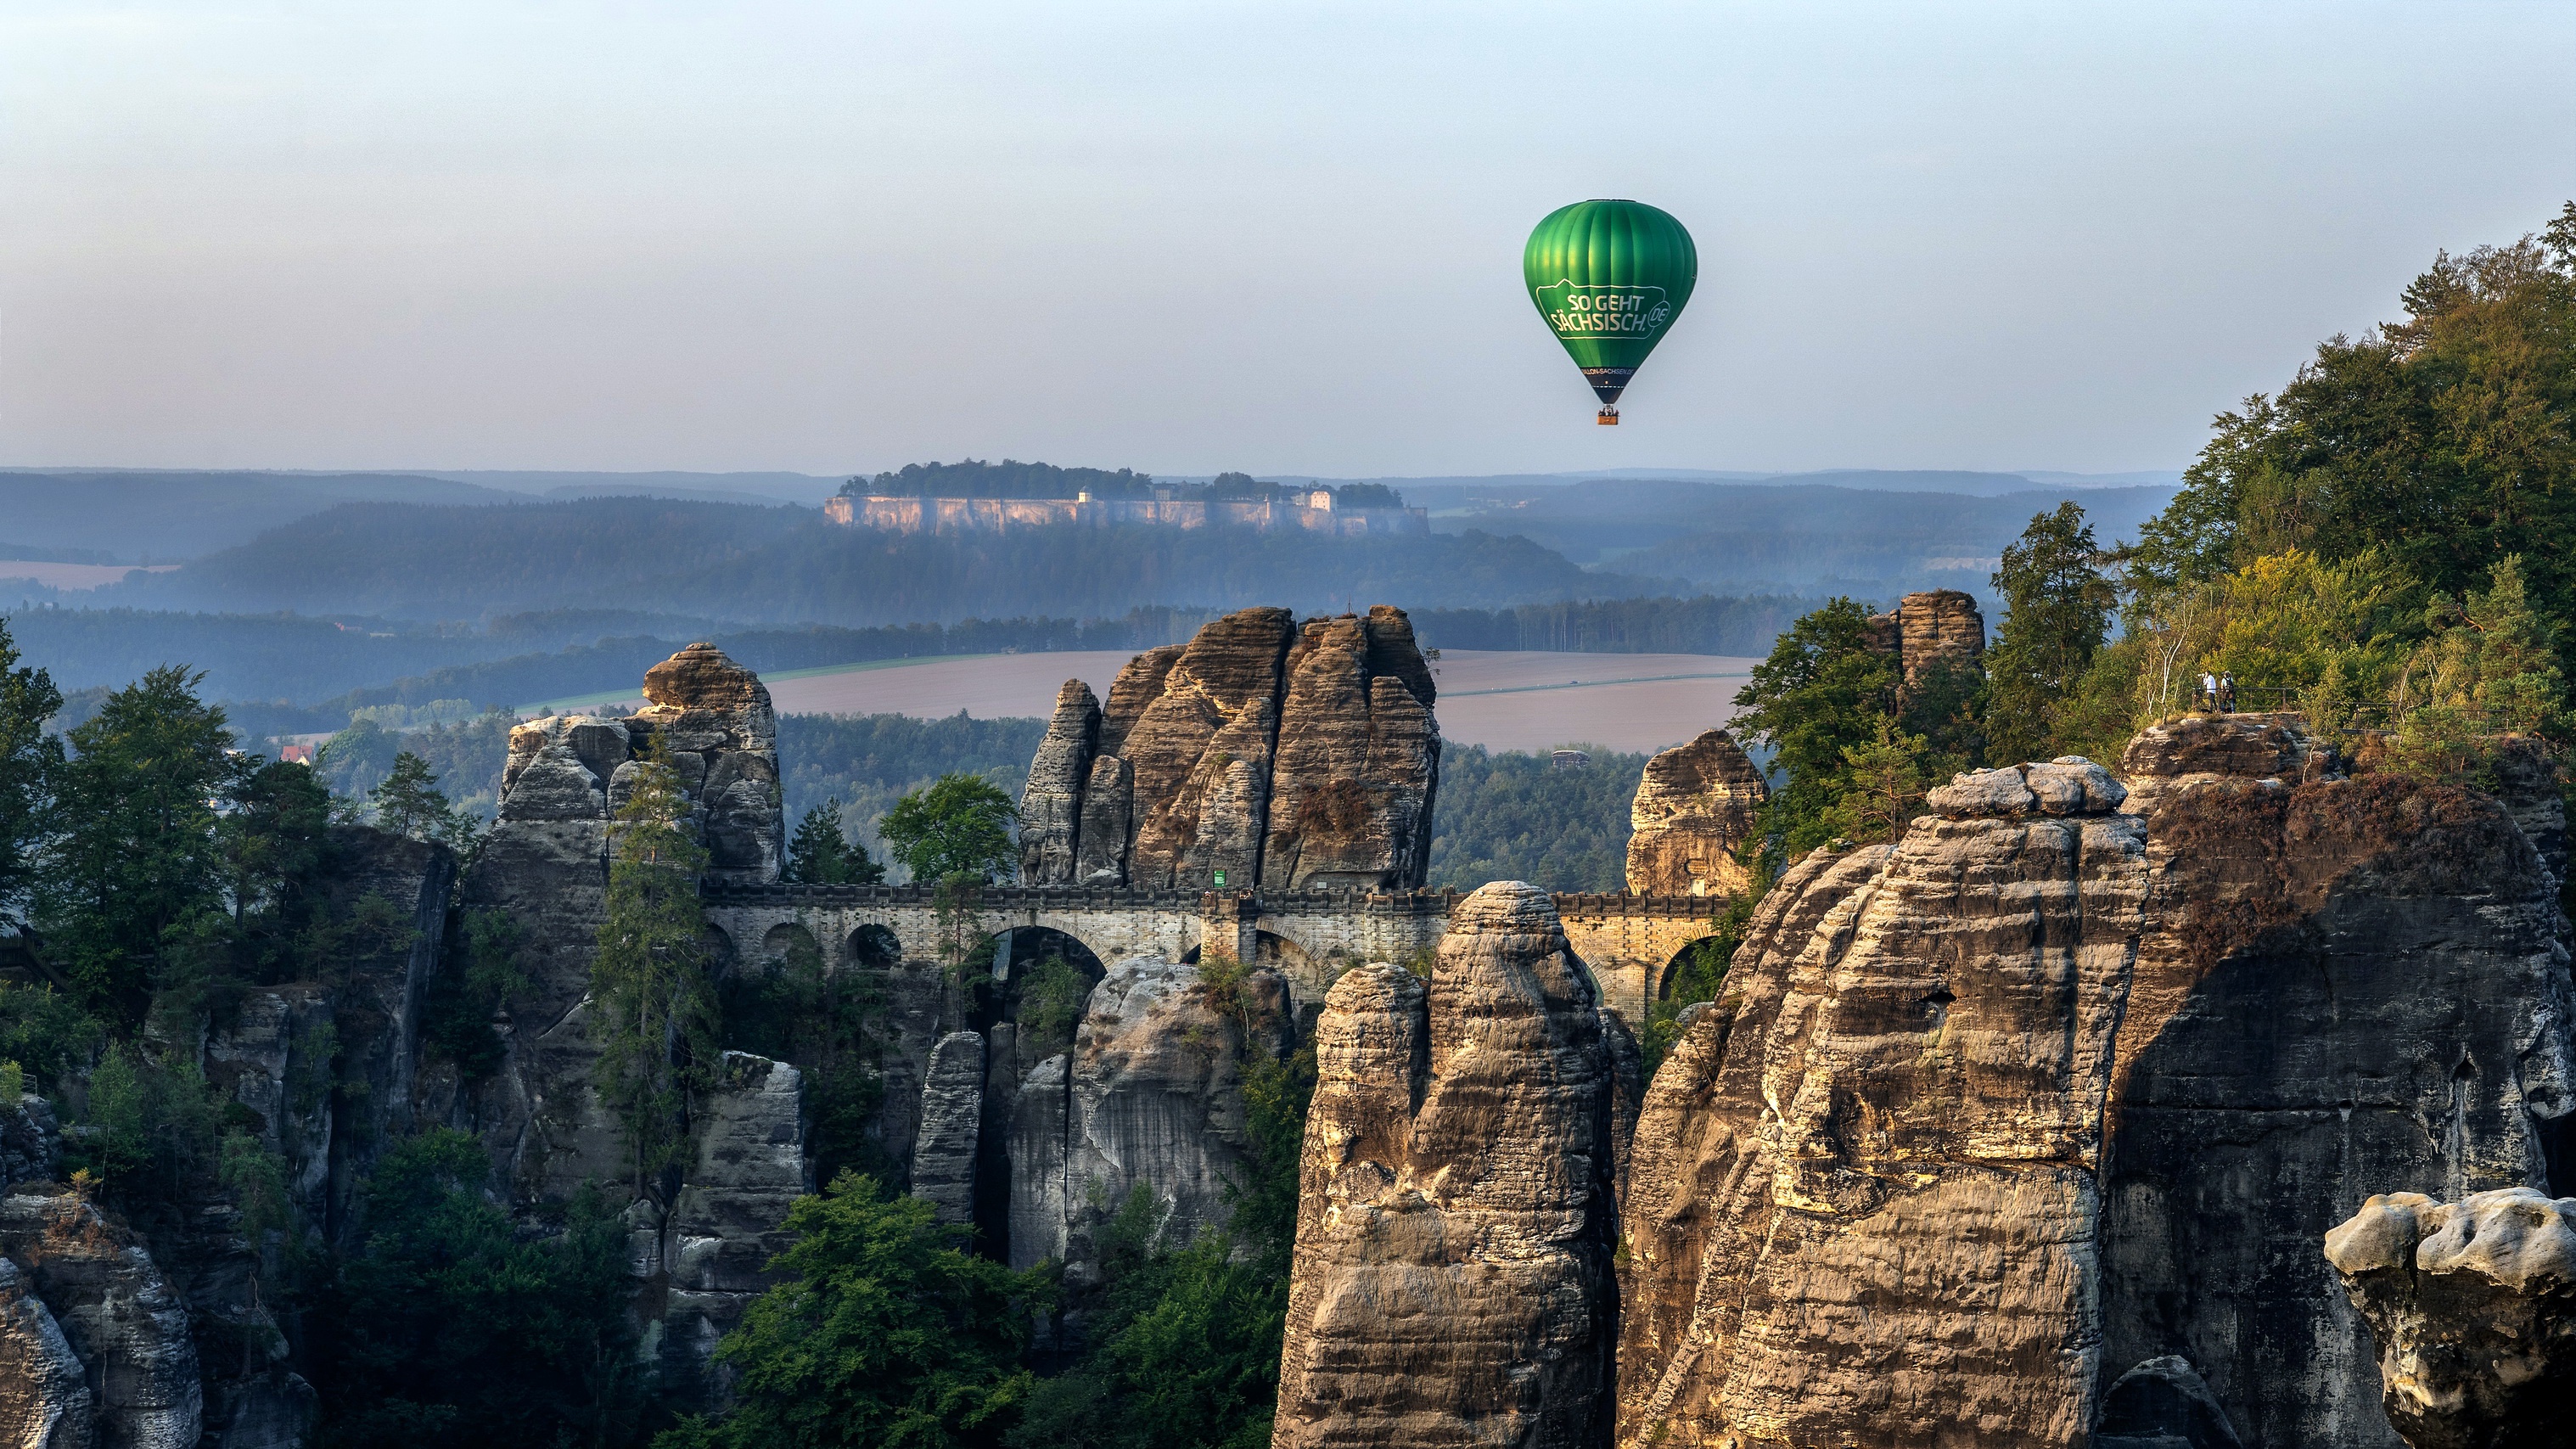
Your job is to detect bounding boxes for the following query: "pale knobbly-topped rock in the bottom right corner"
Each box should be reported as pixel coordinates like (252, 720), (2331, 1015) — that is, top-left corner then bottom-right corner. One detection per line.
(2326, 1188), (2576, 1449)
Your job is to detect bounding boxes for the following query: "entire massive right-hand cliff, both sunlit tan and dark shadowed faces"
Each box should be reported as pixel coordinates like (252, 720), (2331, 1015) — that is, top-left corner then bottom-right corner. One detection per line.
(1618, 716), (2576, 1449)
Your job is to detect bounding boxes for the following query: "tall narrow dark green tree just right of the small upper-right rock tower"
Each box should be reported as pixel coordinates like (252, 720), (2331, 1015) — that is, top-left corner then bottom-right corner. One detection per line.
(1986, 500), (2120, 761)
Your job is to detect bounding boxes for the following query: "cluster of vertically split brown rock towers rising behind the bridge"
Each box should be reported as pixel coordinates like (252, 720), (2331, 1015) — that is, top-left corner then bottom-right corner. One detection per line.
(1020, 606), (1440, 890)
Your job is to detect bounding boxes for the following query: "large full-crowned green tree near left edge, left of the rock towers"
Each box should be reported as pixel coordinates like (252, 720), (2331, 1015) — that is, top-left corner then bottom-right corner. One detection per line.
(33, 668), (239, 1026)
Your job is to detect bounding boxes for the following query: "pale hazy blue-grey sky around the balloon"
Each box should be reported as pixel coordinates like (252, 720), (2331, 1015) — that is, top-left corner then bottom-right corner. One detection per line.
(0, 0), (2576, 475)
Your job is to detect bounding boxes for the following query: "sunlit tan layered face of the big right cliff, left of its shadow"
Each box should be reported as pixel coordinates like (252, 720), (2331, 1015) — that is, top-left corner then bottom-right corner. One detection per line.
(1618, 766), (2148, 1446)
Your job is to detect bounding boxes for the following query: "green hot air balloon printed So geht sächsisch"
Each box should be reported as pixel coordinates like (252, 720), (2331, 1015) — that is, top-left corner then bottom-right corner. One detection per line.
(1520, 201), (1700, 425)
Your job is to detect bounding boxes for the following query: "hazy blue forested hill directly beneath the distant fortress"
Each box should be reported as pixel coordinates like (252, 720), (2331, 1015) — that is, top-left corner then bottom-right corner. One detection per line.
(75, 497), (1672, 626)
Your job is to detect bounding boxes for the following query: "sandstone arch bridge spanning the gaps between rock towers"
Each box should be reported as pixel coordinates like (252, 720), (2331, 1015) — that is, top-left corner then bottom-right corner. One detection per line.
(706, 885), (1726, 1024)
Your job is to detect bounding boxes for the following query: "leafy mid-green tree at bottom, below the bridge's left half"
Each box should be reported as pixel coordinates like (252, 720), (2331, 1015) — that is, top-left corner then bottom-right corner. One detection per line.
(657, 1173), (1048, 1449)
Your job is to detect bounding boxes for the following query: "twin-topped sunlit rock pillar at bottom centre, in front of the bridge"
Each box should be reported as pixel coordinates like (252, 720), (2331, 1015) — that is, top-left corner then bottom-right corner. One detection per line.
(1272, 882), (1615, 1449)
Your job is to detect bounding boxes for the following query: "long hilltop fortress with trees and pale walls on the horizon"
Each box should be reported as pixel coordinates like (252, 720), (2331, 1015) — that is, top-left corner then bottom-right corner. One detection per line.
(822, 459), (1429, 536)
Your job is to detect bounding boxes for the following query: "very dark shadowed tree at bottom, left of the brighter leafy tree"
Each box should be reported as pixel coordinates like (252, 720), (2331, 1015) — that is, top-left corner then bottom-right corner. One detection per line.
(306, 1126), (647, 1449)
